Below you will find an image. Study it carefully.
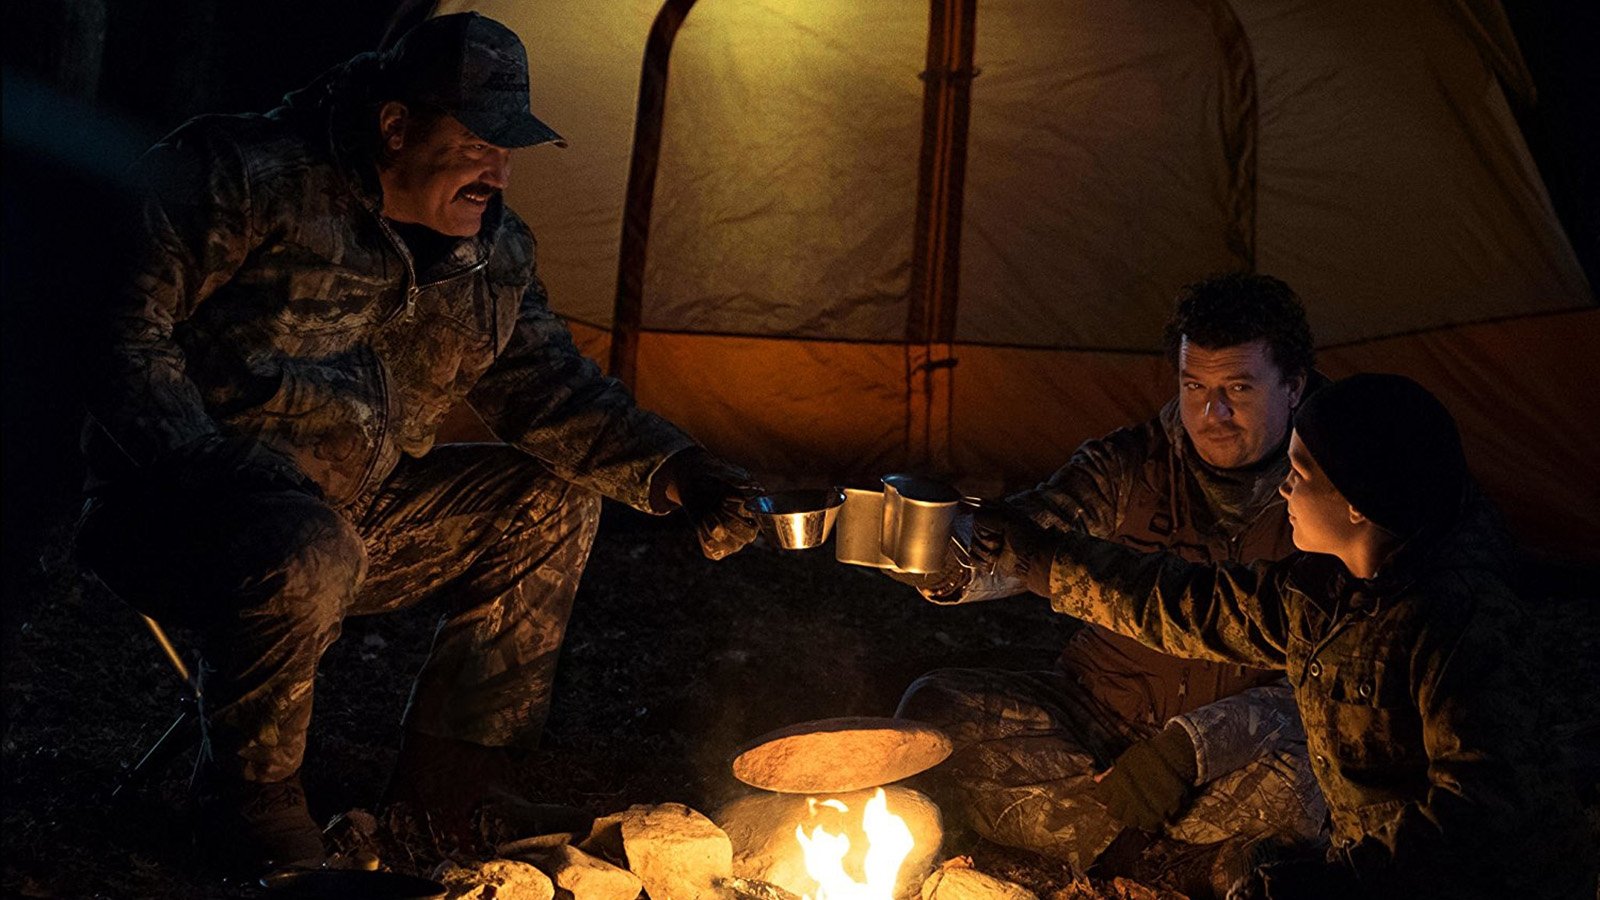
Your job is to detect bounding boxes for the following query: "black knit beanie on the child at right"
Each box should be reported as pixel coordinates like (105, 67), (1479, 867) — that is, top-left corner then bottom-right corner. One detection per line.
(1294, 373), (1467, 538)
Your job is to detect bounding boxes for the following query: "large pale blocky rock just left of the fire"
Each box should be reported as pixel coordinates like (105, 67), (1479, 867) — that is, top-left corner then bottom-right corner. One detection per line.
(614, 804), (733, 900)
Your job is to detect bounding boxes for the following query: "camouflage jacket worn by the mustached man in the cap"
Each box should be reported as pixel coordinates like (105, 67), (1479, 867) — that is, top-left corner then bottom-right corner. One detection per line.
(85, 56), (693, 509)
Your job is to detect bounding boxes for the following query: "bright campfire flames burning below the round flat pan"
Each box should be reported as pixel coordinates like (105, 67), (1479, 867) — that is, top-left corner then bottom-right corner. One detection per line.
(795, 788), (915, 900)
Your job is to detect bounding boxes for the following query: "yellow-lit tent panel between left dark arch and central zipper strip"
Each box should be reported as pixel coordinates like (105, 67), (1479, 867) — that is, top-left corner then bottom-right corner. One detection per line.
(643, 0), (928, 340)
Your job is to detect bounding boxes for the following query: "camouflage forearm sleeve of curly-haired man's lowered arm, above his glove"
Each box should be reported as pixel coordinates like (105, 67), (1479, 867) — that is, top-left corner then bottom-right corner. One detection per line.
(1171, 681), (1306, 785)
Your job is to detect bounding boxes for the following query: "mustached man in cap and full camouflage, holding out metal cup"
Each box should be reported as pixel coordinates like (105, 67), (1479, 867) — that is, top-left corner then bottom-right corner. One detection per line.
(68, 13), (755, 868)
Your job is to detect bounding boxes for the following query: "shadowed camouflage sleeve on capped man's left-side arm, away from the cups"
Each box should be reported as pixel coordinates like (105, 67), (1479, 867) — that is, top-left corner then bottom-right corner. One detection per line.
(86, 127), (258, 466)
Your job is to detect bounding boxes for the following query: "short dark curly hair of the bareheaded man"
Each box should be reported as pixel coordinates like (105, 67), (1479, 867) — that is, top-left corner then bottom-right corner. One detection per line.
(1162, 272), (1317, 380)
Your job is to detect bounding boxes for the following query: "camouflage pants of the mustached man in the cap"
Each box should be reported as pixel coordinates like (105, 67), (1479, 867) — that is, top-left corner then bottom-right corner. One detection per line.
(80, 444), (600, 781)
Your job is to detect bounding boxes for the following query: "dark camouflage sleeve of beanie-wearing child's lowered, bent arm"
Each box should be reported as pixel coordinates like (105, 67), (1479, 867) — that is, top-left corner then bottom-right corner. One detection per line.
(1347, 596), (1563, 897)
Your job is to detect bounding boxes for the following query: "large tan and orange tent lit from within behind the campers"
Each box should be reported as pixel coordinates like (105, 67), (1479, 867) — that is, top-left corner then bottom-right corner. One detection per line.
(440, 0), (1600, 560)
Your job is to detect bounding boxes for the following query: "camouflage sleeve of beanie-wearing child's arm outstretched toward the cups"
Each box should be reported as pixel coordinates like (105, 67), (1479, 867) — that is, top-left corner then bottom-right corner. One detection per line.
(1050, 533), (1296, 669)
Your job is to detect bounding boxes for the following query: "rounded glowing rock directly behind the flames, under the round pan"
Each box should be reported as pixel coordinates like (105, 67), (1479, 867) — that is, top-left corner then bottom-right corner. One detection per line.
(715, 785), (944, 897)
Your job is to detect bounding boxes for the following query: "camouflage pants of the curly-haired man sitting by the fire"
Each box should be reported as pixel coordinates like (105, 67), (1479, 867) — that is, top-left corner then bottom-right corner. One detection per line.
(896, 669), (1326, 873)
